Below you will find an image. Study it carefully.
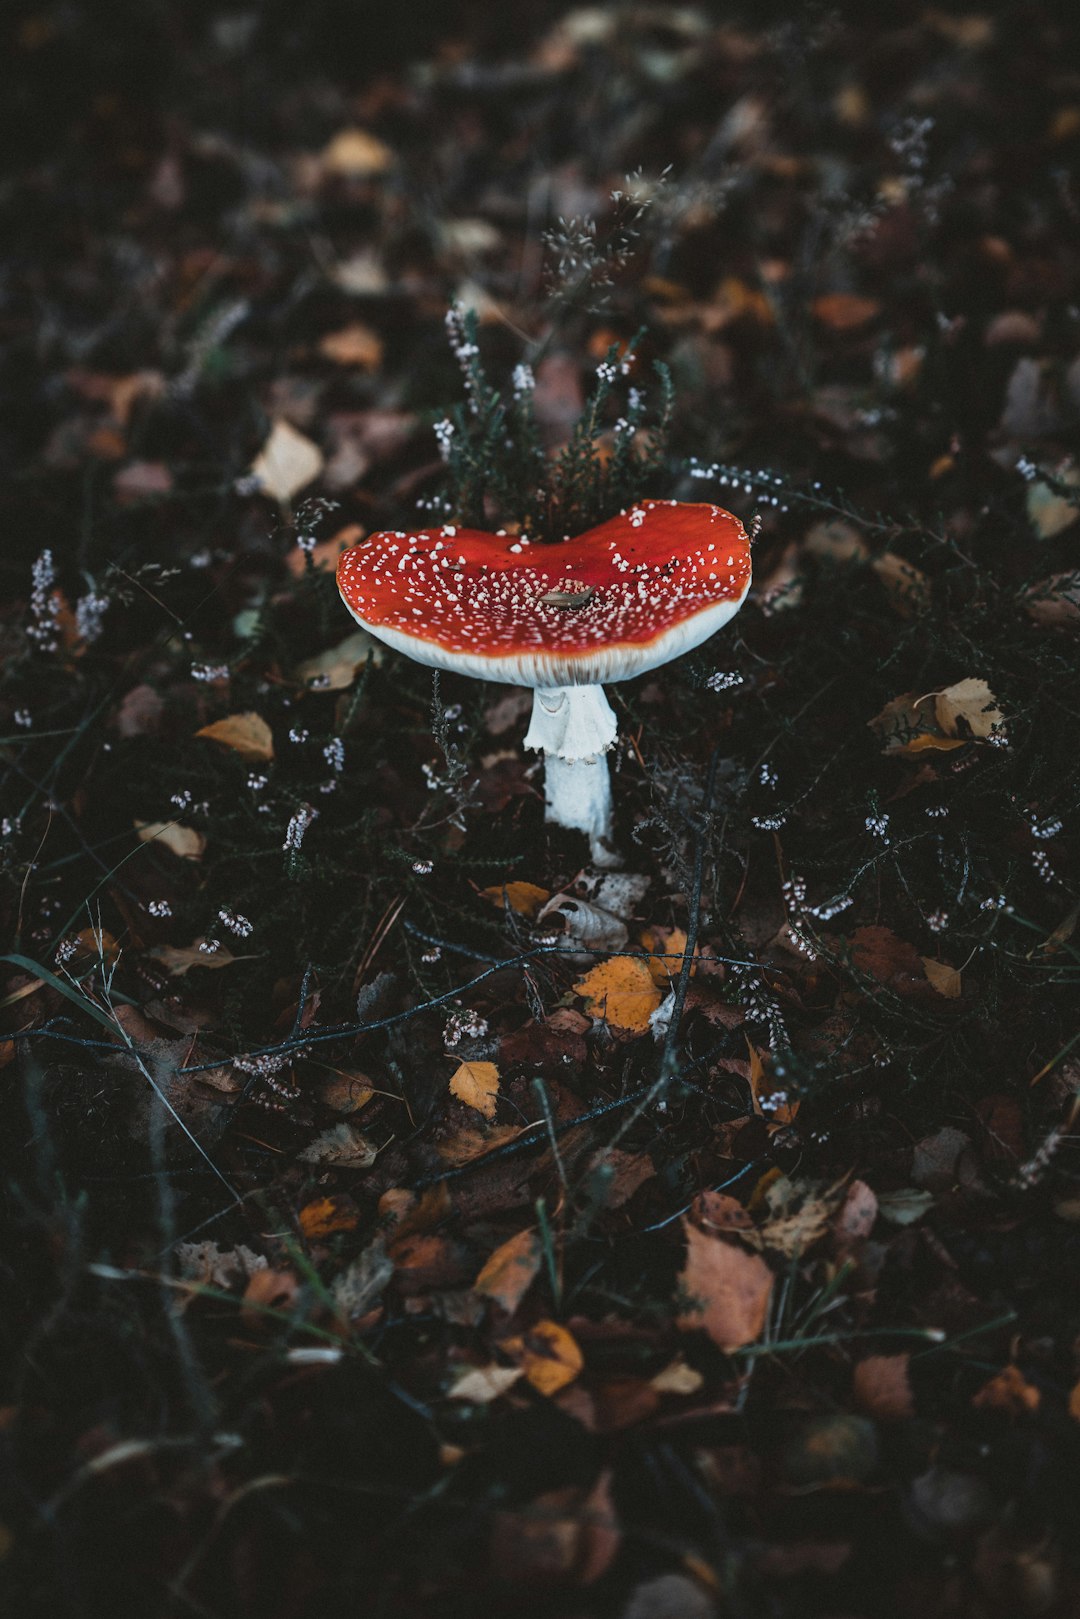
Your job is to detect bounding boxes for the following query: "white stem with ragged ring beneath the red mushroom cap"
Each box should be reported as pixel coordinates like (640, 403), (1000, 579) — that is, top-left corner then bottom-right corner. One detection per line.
(525, 686), (619, 866)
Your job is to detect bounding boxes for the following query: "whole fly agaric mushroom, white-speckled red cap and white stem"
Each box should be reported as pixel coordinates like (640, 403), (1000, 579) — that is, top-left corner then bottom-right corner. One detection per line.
(337, 500), (750, 865)
